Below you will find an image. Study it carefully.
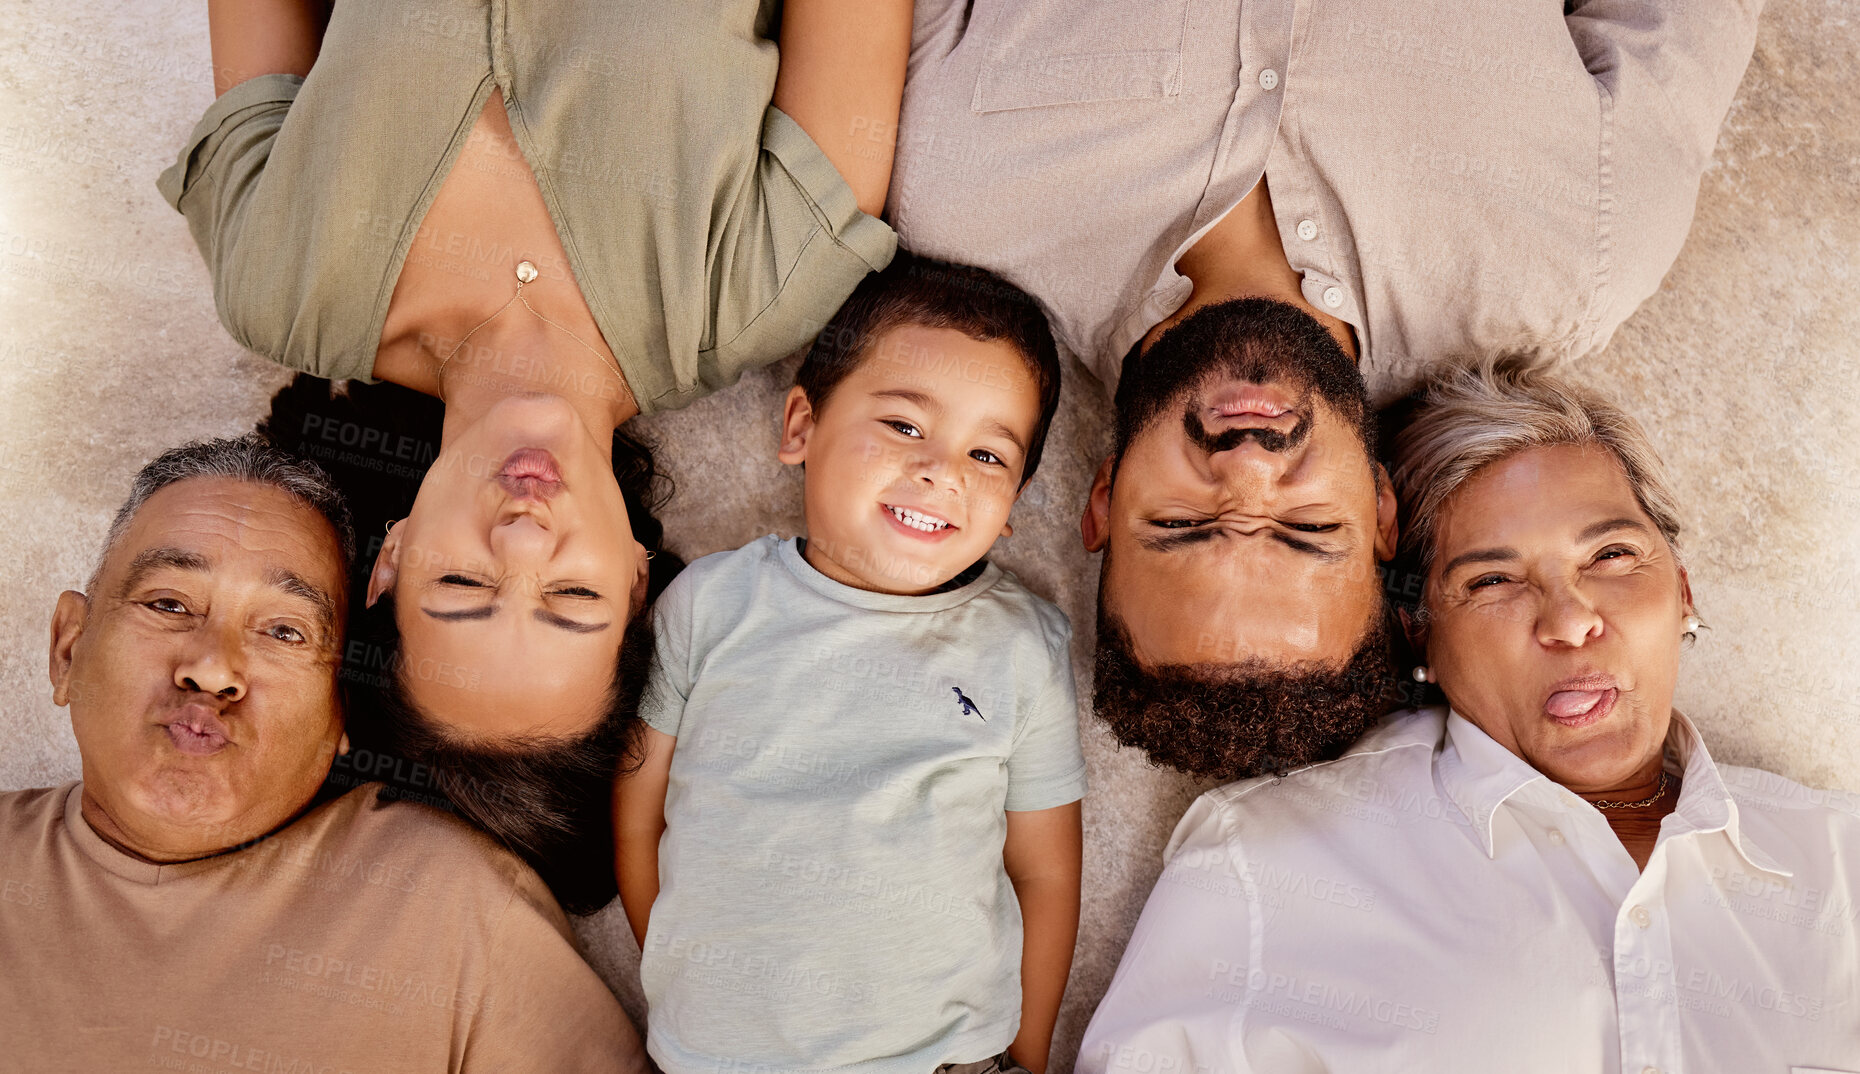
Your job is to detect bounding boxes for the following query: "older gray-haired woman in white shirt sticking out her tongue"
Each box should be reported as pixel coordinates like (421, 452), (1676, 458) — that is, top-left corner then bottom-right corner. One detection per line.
(1079, 361), (1860, 1074)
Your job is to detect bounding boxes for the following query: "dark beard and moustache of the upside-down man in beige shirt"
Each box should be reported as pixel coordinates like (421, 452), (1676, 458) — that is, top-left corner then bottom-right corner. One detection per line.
(1116, 298), (1375, 456)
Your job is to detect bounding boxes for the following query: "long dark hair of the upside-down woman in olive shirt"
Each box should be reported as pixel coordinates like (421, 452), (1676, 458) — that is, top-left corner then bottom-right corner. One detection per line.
(259, 376), (684, 914)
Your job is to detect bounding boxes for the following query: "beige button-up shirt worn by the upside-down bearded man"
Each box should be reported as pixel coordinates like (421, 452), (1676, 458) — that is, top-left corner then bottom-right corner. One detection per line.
(891, 0), (1761, 402)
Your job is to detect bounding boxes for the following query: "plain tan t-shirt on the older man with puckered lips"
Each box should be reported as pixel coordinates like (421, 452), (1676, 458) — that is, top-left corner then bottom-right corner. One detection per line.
(0, 784), (642, 1074)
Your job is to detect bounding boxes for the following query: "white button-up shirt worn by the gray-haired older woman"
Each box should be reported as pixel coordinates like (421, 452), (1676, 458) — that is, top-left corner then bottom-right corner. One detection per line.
(1077, 709), (1860, 1074)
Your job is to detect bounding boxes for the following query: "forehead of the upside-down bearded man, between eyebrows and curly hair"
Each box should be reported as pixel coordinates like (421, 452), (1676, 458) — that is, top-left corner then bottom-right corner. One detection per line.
(1097, 530), (1382, 668)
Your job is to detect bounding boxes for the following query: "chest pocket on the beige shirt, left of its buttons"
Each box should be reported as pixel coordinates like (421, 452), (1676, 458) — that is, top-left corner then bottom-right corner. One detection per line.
(962, 0), (1189, 114)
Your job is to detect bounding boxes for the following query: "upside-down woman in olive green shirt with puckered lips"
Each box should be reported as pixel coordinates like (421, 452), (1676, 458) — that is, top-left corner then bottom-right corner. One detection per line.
(171, 0), (911, 904)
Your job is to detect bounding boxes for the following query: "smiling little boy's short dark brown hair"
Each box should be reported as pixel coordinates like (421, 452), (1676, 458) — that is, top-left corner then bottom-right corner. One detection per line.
(794, 249), (1058, 486)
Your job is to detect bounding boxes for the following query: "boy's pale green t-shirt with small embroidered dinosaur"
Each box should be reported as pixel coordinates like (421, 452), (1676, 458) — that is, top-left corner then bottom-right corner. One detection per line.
(640, 536), (1084, 1074)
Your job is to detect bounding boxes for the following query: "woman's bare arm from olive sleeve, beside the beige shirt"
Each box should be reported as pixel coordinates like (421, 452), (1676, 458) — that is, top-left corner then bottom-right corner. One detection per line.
(774, 0), (911, 216)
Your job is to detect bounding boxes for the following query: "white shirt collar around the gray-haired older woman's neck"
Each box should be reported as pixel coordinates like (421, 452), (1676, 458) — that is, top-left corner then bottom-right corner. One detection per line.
(1434, 709), (1791, 877)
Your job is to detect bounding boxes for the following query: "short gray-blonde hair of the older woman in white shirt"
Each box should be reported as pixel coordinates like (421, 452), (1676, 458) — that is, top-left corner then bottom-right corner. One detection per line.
(1393, 356), (1680, 577)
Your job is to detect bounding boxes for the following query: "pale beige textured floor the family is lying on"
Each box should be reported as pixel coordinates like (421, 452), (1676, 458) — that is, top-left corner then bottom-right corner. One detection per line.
(0, 0), (1860, 1070)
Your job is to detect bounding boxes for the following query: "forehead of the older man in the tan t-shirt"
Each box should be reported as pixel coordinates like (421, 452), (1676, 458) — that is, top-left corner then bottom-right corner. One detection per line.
(99, 477), (344, 601)
